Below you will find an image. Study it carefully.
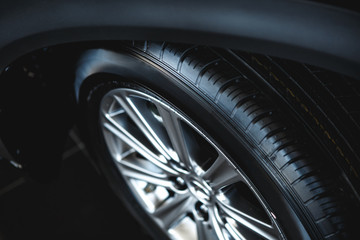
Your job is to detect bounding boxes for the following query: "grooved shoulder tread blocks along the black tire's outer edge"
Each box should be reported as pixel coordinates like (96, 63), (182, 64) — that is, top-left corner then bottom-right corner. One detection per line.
(128, 42), (352, 240)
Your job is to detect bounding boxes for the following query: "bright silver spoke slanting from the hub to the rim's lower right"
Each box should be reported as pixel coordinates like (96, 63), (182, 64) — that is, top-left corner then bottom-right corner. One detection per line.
(218, 201), (277, 239)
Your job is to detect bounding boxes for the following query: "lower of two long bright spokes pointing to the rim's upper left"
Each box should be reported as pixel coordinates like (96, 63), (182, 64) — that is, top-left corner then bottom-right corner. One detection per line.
(104, 114), (176, 174)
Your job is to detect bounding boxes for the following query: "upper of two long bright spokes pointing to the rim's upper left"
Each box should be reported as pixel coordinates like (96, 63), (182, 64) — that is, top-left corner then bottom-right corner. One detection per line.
(114, 95), (171, 160)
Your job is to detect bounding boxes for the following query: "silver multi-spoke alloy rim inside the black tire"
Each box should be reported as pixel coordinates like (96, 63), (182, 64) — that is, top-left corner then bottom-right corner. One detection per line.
(100, 88), (282, 240)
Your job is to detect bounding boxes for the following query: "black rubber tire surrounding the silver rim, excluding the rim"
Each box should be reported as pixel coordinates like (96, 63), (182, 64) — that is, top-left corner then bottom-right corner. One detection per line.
(80, 42), (359, 240)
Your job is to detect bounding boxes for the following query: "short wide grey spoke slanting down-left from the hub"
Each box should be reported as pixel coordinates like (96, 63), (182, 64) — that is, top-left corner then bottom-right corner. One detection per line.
(153, 192), (195, 229)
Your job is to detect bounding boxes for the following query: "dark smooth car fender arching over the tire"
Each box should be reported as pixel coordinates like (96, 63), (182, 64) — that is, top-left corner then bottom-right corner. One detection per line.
(0, 0), (360, 79)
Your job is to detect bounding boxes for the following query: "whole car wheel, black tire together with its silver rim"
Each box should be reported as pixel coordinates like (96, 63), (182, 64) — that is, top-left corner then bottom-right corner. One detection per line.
(79, 42), (359, 240)
